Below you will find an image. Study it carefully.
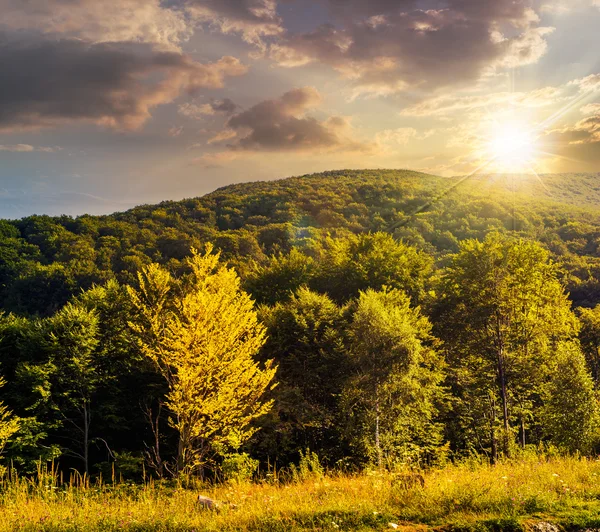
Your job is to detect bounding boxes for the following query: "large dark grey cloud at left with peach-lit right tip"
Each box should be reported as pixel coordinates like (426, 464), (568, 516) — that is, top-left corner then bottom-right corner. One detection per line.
(0, 35), (247, 132)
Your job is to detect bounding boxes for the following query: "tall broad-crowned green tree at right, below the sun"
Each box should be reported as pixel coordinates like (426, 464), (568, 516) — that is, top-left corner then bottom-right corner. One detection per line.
(436, 234), (578, 460)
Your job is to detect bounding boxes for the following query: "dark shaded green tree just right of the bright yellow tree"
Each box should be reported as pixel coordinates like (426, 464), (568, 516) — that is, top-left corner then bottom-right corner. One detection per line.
(259, 287), (349, 461)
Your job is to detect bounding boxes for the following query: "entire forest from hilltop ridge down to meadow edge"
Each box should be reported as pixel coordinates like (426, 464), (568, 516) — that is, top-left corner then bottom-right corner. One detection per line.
(0, 170), (600, 482)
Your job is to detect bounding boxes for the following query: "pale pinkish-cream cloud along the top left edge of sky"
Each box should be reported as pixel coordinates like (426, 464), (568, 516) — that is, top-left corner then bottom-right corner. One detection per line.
(0, 0), (192, 48)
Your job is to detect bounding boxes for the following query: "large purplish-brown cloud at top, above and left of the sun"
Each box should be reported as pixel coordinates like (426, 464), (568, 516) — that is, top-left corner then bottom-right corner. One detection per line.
(270, 0), (551, 95)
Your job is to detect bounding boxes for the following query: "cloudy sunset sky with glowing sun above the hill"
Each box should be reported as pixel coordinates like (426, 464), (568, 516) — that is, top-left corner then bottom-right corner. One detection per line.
(0, 0), (600, 218)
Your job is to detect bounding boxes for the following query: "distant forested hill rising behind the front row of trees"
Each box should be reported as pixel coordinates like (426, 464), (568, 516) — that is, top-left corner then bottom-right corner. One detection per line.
(0, 170), (600, 315)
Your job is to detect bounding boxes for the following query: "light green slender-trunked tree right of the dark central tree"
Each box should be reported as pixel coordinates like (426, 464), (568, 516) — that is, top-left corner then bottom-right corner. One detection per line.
(345, 288), (443, 467)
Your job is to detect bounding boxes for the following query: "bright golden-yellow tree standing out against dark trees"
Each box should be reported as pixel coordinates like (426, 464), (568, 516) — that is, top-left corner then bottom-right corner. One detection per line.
(128, 246), (276, 474)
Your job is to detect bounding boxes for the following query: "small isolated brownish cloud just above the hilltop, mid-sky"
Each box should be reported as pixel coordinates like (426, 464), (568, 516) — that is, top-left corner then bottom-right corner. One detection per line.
(212, 87), (371, 152)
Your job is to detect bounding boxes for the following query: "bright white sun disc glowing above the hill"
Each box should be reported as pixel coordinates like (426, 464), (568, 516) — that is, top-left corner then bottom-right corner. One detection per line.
(487, 123), (537, 171)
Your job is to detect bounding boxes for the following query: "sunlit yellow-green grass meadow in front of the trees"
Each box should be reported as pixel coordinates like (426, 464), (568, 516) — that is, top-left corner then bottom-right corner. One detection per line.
(0, 457), (600, 532)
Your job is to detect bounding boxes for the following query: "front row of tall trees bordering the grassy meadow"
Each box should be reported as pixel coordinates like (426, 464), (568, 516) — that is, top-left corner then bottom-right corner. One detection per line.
(0, 232), (600, 478)
